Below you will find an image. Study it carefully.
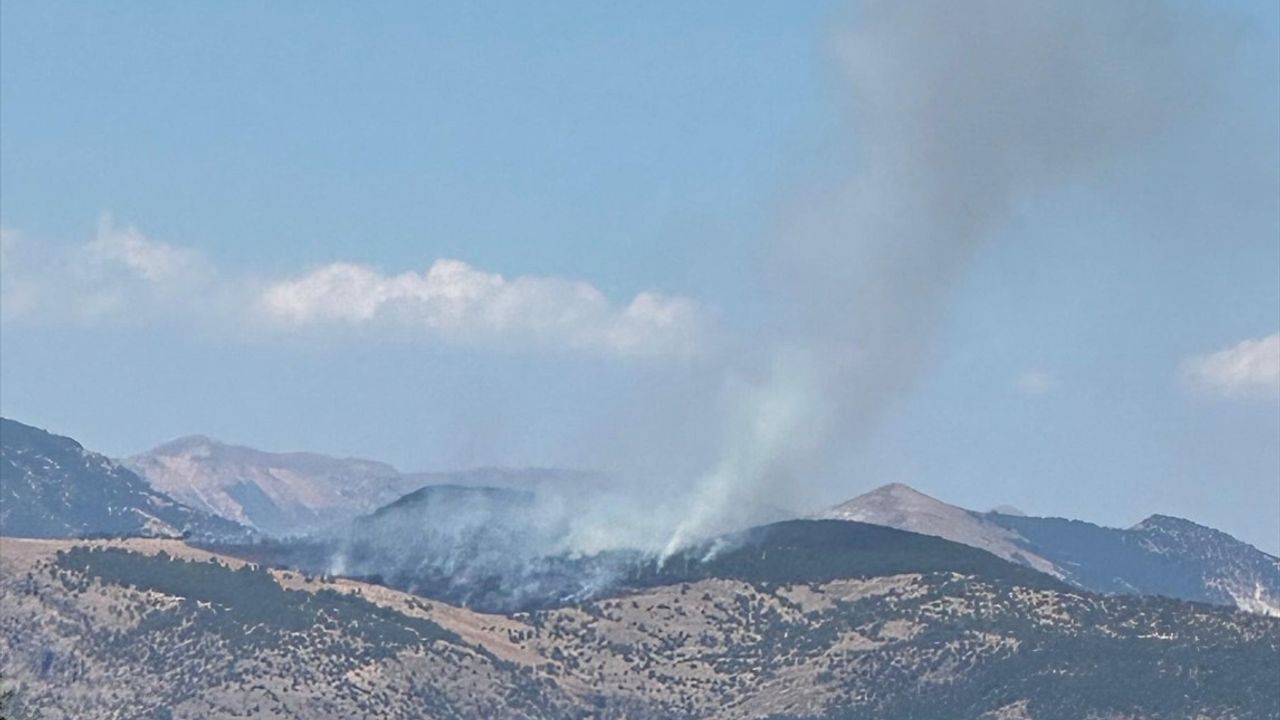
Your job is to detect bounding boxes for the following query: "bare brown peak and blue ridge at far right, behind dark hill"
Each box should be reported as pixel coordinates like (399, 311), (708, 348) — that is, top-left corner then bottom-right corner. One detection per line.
(820, 484), (1280, 616)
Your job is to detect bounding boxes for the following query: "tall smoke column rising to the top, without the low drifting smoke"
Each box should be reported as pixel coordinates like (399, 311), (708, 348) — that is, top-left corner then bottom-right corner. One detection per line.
(668, 0), (1221, 552)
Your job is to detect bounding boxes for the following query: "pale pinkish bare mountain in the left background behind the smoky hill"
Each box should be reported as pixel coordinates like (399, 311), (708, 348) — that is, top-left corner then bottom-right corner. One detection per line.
(124, 436), (593, 536)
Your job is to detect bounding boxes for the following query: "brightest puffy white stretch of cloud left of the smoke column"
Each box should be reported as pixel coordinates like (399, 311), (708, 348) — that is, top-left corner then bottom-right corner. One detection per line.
(259, 259), (703, 356)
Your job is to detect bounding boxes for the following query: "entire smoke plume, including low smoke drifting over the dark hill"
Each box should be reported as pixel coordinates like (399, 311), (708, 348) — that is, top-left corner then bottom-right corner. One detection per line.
(293, 0), (1239, 594)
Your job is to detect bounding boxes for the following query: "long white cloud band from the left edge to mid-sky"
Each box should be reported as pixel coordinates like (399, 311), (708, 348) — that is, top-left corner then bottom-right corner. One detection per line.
(0, 215), (708, 357)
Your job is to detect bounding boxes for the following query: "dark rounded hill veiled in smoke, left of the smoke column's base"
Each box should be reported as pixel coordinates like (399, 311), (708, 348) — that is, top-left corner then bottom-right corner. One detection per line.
(216, 486), (606, 612)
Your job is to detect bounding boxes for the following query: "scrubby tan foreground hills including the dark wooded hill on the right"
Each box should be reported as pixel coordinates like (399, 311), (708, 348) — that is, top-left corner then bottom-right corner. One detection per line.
(0, 521), (1280, 720)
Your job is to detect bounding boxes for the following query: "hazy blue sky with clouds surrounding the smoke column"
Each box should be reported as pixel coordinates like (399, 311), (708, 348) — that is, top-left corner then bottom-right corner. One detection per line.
(0, 3), (1280, 552)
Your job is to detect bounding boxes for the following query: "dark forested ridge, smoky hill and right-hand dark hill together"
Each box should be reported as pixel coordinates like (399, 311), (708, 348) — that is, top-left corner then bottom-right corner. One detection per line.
(238, 499), (1057, 612)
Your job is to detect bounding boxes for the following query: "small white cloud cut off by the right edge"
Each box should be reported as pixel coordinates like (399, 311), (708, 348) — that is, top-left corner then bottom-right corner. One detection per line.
(1181, 333), (1280, 398)
